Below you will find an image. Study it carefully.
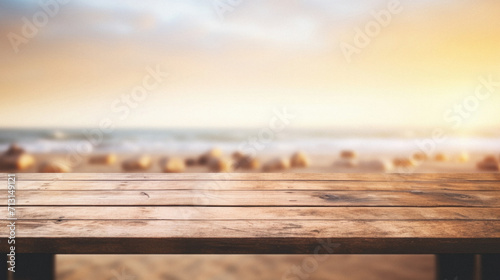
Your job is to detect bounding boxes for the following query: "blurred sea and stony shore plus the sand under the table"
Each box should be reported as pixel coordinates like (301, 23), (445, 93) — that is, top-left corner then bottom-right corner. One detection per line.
(0, 129), (500, 280)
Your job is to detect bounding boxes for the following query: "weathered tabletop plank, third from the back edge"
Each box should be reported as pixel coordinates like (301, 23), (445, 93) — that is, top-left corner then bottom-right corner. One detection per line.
(0, 190), (500, 207)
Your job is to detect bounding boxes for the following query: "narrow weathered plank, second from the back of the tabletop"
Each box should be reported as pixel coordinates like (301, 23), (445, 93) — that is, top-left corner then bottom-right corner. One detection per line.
(10, 181), (500, 191)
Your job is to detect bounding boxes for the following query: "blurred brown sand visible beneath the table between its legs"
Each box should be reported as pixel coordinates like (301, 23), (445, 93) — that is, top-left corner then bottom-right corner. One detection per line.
(56, 255), (435, 280)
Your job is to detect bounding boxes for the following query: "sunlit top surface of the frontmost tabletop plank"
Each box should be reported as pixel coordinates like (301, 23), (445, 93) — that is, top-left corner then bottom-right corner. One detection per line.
(0, 220), (500, 237)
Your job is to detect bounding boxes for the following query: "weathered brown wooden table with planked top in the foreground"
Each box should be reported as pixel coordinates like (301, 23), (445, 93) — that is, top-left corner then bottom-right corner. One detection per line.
(0, 173), (500, 280)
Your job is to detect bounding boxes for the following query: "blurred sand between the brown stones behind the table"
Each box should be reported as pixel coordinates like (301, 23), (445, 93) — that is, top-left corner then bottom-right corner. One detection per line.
(2, 153), (495, 173)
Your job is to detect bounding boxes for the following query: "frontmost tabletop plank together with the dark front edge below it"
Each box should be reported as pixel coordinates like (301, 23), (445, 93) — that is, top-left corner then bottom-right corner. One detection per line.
(0, 220), (500, 254)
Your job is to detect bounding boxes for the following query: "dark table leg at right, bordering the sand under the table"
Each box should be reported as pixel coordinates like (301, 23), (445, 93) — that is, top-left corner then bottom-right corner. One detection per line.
(436, 254), (475, 280)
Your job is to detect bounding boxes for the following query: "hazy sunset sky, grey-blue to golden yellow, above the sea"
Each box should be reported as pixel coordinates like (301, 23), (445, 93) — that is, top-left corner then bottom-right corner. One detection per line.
(0, 0), (500, 130)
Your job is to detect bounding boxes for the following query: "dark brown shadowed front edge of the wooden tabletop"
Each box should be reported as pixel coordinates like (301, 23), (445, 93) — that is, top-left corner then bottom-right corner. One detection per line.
(7, 237), (500, 254)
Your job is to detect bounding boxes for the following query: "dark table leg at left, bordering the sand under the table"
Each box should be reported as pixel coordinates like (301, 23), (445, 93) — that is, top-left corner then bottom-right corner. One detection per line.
(7, 254), (55, 280)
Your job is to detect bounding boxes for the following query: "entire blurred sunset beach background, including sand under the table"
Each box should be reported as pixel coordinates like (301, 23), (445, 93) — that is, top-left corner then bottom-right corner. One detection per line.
(0, 0), (500, 279)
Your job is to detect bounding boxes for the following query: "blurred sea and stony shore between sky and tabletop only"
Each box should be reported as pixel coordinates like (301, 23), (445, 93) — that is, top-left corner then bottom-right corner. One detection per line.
(0, 129), (500, 173)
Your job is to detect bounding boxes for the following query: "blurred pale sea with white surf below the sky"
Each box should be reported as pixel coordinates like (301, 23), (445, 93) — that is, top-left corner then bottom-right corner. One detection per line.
(0, 129), (500, 155)
